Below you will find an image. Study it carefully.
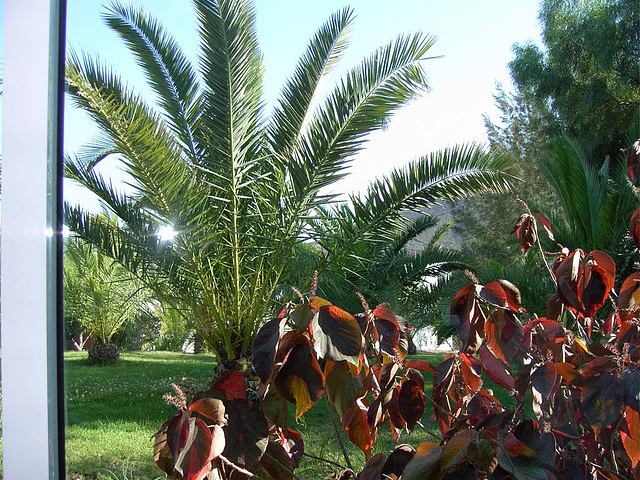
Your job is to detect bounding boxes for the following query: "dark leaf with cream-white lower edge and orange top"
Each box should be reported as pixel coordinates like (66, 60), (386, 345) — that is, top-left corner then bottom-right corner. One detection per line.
(311, 305), (364, 366)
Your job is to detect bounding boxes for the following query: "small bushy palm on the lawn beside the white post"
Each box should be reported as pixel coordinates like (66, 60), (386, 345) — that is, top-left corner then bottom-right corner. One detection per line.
(63, 239), (148, 360)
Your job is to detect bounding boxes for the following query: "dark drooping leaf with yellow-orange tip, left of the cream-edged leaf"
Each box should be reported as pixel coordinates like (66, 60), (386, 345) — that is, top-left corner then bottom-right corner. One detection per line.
(273, 331), (325, 420)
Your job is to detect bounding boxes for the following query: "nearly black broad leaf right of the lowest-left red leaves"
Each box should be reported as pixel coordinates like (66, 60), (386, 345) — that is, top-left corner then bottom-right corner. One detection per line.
(224, 399), (269, 466)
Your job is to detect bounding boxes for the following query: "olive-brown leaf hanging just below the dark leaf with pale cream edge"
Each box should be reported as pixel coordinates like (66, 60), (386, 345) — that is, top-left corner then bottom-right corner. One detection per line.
(324, 360), (367, 420)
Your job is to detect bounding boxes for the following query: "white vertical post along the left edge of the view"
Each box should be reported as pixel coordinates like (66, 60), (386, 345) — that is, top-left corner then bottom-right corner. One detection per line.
(1, 0), (64, 480)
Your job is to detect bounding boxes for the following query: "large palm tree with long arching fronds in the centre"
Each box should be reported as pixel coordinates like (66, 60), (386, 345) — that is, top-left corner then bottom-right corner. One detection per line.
(65, 0), (512, 358)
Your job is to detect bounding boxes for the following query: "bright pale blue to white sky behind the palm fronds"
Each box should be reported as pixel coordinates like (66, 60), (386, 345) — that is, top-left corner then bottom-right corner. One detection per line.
(65, 0), (540, 206)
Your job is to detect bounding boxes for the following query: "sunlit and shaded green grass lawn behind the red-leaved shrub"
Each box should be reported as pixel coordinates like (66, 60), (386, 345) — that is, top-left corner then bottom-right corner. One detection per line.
(65, 352), (510, 480)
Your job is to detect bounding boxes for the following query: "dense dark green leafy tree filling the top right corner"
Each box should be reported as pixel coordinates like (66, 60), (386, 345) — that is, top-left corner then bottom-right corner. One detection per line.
(509, 0), (640, 160)
